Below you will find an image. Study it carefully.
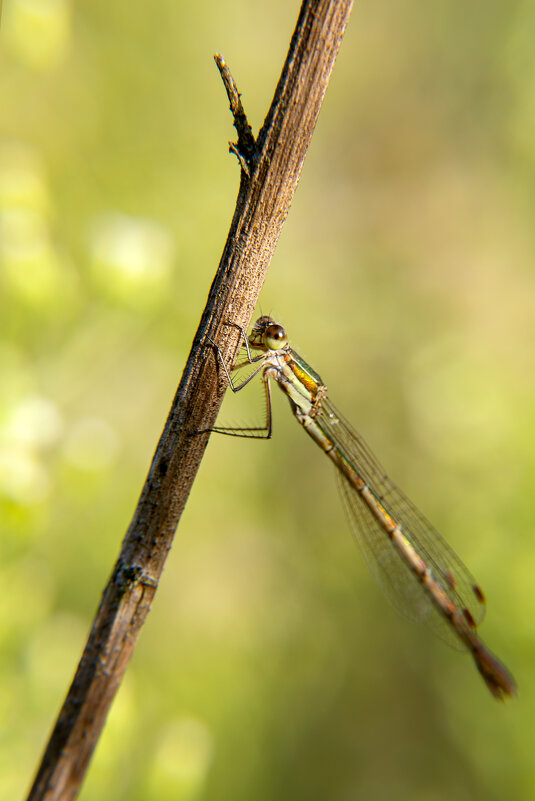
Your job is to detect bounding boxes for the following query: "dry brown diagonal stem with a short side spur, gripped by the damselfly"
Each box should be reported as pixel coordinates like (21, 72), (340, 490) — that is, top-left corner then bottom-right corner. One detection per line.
(29, 0), (352, 801)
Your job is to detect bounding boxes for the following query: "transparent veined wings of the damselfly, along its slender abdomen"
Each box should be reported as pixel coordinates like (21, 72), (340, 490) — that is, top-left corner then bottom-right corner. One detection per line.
(316, 399), (485, 648)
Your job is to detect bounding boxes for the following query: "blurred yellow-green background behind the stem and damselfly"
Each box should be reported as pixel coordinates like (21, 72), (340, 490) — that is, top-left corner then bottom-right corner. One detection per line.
(0, 0), (535, 801)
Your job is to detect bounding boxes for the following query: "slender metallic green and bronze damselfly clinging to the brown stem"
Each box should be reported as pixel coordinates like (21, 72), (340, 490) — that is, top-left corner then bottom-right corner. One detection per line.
(210, 315), (516, 700)
